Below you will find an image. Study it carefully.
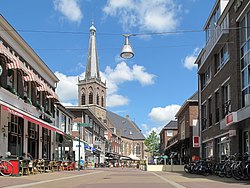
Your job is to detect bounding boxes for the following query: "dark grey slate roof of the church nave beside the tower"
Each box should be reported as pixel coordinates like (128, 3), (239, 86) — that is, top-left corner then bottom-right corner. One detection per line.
(107, 110), (145, 140)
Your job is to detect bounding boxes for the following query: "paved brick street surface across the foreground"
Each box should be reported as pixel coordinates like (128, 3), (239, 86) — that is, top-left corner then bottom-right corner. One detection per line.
(0, 168), (250, 188)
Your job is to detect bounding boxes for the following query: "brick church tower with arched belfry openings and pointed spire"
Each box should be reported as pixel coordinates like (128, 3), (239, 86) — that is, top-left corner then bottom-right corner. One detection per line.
(78, 22), (106, 121)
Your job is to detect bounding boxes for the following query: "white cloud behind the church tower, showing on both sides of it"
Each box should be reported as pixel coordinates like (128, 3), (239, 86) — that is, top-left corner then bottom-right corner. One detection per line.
(55, 62), (155, 107)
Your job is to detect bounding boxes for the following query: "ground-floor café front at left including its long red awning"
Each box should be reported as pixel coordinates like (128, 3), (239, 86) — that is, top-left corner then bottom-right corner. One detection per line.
(0, 100), (64, 159)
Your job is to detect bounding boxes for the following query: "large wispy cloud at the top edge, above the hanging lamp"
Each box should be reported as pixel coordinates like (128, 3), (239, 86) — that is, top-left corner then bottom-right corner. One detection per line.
(103, 0), (181, 32)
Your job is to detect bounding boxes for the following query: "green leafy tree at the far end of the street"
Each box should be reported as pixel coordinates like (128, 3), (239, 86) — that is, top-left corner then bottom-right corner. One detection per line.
(144, 131), (160, 158)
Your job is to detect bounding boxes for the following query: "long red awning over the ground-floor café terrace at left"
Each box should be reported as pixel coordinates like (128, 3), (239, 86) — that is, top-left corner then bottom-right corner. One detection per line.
(2, 105), (64, 135)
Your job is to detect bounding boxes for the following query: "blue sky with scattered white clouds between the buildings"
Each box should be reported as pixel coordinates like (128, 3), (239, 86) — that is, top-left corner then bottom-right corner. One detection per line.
(0, 0), (215, 135)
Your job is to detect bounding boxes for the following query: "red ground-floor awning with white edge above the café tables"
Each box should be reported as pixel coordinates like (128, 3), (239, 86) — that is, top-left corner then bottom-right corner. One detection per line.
(0, 103), (64, 135)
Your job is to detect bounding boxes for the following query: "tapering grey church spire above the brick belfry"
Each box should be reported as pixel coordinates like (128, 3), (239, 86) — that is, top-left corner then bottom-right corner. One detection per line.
(85, 21), (101, 80)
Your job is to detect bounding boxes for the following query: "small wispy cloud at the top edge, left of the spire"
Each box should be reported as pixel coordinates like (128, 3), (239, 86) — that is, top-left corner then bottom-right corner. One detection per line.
(54, 0), (83, 23)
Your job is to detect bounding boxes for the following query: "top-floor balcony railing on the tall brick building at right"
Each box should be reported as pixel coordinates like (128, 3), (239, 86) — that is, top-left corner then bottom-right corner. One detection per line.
(201, 13), (229, 65)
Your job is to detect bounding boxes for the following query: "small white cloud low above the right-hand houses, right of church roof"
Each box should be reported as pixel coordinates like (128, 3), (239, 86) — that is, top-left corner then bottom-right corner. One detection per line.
(149, 104), (181, 124)
